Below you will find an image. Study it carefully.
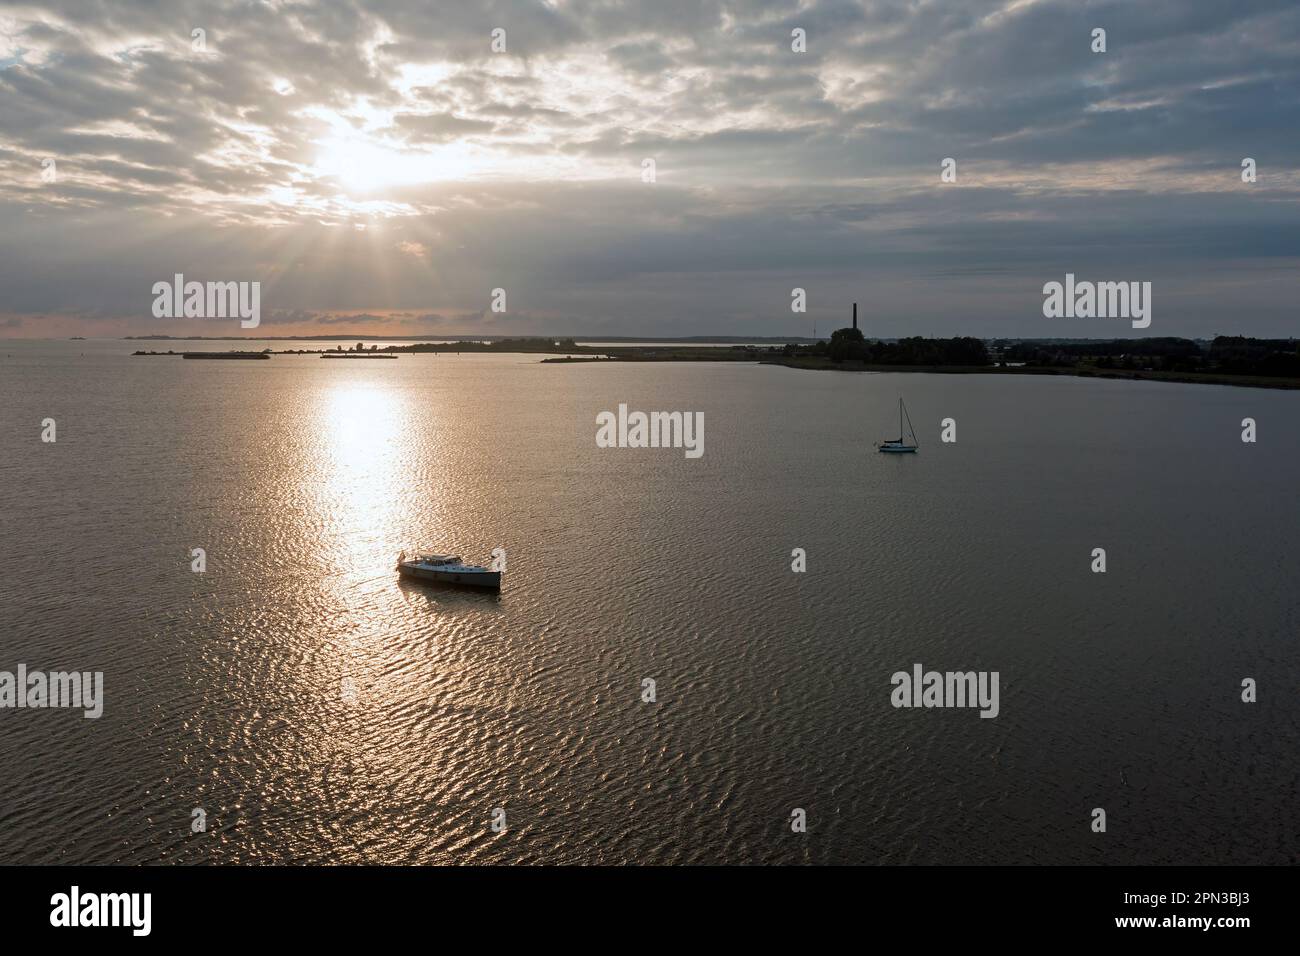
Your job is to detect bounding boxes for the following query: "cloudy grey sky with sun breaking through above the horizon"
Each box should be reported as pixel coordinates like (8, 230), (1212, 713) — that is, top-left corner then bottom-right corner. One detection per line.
(0, 0), (1300, 337)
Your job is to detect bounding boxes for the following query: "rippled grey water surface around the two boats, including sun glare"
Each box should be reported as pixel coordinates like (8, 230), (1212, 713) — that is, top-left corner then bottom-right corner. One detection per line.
(0, 342), (1300, 864)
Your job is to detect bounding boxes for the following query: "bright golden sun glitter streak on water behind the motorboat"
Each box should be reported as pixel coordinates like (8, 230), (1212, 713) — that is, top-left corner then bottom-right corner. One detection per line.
(261, 374), (528, 862)
